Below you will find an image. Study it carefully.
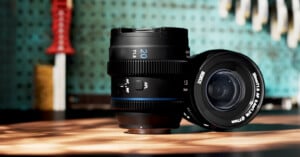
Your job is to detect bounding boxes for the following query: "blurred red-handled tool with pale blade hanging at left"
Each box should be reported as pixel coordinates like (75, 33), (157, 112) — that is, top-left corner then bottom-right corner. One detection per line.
(46, 0), (74, 111)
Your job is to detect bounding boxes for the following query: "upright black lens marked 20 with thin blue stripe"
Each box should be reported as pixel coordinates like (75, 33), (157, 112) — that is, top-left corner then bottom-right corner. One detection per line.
(108, 28), (189, 134)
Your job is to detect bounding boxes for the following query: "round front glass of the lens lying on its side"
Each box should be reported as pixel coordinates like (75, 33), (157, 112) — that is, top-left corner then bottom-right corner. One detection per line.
(206, 69), (244, 110)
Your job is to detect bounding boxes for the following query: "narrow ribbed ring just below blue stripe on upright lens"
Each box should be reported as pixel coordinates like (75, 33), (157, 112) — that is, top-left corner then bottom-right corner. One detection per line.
(111, 100), (184, 113)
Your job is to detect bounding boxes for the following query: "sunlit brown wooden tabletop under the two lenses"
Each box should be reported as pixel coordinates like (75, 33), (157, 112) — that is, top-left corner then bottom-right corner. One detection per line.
(0, 110), (300, 155)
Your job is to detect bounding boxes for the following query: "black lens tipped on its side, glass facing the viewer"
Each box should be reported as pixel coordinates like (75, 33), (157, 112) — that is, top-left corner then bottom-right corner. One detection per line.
(184, 50), (264, 130)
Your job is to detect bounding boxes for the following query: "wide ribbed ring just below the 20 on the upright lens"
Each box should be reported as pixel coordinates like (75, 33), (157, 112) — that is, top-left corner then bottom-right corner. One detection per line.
(108, 59), (187, 76)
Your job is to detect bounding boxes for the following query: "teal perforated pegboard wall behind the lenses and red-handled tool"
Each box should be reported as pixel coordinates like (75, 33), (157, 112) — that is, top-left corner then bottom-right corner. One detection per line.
(0, 0), (300, 109)
